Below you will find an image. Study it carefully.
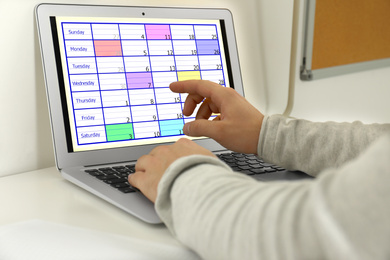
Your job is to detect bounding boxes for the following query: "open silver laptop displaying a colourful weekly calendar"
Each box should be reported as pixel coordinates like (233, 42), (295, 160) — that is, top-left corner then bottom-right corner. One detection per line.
(35, 4), (308, 223)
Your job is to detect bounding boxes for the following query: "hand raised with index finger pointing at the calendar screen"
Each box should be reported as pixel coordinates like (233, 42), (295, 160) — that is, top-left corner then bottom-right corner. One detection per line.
(170, 80), (264, 153)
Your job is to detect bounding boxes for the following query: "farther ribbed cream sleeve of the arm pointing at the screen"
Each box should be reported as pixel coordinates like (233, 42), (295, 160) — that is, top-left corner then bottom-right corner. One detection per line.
(258, 115), (390, 175)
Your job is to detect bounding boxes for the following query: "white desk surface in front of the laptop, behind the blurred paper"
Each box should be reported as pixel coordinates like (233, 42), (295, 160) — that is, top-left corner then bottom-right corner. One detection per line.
(0, 167), (180, 246)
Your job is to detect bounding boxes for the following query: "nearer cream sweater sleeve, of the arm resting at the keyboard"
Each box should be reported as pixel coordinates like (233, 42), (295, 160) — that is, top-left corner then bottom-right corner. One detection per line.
(156, 116), (390, 260)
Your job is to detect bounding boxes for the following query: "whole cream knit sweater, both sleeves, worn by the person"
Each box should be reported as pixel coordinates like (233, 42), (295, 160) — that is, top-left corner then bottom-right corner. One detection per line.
(155, 115), (390, 260)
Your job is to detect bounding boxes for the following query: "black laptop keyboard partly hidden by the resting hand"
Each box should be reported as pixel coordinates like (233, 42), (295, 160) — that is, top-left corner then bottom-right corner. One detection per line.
(85, 152), (285, 193)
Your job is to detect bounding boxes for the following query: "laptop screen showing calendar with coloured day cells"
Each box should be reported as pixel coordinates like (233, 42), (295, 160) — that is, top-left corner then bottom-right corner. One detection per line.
(50, 16), (233, 152)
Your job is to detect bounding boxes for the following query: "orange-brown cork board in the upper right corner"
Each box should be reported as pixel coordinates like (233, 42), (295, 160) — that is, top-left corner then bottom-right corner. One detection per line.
(303, 0), (390, 80)
